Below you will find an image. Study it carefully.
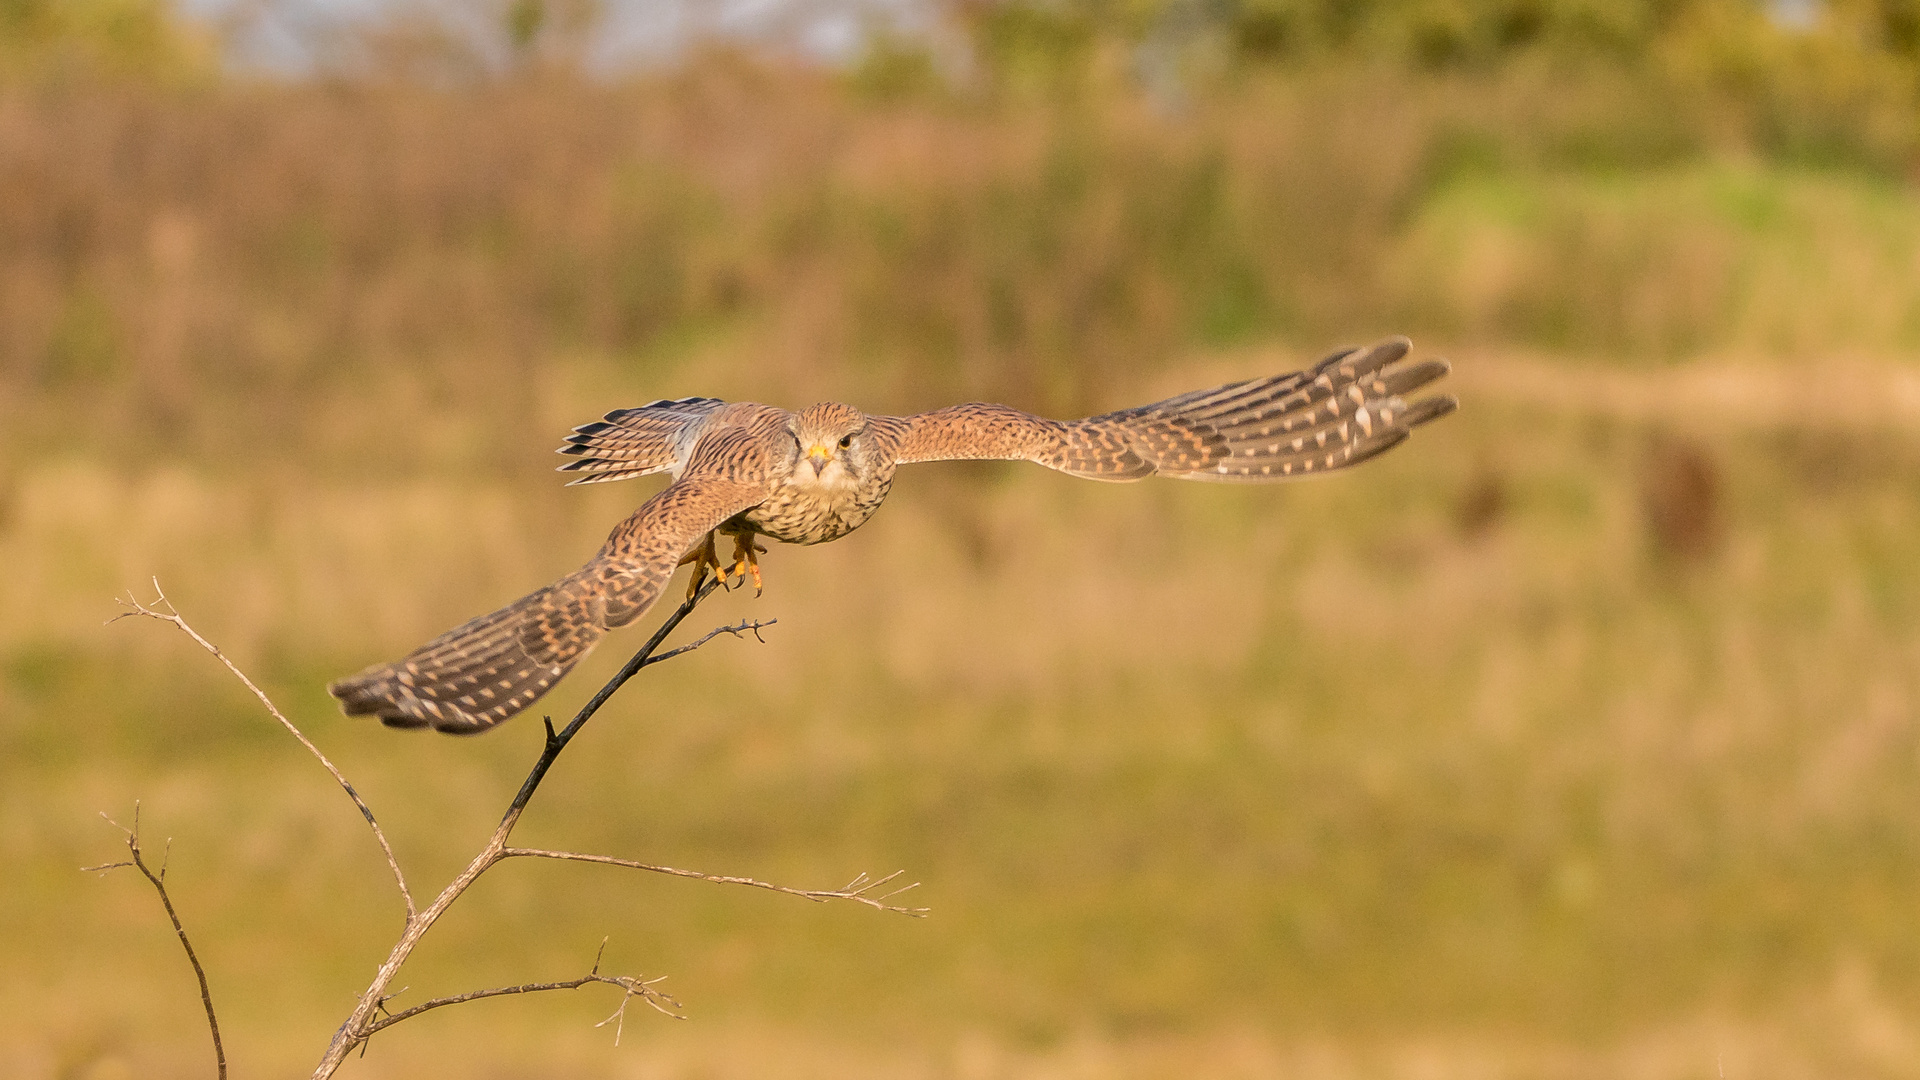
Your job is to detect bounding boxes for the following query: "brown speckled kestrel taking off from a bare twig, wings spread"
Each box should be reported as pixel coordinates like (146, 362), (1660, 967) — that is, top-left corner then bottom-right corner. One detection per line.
(326, 338), (1457, 734)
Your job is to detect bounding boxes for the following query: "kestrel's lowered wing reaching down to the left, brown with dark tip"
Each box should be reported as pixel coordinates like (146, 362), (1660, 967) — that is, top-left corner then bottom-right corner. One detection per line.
(326, 461), (766, 734)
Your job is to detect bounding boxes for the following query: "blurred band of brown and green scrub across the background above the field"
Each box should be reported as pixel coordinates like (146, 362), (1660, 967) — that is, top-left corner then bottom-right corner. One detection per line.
(11, 0), (1920, 478)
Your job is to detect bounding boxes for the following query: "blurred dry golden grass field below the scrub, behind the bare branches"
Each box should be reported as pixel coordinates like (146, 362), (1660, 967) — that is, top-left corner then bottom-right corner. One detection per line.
(4, 354), (1920, 1076)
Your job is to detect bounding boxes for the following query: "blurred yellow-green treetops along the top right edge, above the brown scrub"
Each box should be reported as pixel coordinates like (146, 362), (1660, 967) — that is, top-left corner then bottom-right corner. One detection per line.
(958, 0), (1920, 171)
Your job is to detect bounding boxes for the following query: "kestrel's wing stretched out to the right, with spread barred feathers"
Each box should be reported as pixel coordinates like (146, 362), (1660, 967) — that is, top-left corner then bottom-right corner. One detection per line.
(897, 338), (1459, 482)
